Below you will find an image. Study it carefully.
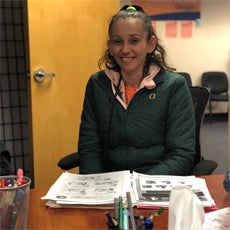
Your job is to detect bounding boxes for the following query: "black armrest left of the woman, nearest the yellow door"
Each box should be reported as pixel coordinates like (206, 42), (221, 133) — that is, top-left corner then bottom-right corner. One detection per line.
(57, 152), (80, 170)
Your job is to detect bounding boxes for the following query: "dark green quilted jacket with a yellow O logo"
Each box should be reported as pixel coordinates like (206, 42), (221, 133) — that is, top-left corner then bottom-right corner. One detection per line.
(78, 67), (195, 175)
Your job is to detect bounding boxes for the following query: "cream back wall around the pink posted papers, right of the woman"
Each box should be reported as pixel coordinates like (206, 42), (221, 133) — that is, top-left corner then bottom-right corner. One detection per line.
(156, 0), (230, 112)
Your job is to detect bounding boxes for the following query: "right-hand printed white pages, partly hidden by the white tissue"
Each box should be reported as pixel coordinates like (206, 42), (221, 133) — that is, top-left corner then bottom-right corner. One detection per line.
(133, 172), (215, 207)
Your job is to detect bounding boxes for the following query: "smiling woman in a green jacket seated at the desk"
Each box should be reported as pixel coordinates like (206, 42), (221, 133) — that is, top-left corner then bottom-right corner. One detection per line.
(78, 6), (195, 175)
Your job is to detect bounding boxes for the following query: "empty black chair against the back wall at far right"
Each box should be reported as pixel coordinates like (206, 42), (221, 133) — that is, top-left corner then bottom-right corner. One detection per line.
(201, 71), (229, 121)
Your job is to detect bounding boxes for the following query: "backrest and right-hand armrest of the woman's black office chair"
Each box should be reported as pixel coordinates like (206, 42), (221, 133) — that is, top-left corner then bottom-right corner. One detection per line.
(189, 86), (217, 176)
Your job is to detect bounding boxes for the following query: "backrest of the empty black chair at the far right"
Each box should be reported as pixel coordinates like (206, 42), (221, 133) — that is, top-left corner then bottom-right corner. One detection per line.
(201, 71), (228, 94)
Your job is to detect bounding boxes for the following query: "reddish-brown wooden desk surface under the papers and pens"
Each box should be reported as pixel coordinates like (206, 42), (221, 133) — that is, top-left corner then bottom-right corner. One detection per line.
(27, 175), (230, 230)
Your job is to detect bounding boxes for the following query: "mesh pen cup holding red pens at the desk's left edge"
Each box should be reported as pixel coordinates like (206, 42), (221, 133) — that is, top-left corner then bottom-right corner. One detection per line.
(0, 176), (31, 230)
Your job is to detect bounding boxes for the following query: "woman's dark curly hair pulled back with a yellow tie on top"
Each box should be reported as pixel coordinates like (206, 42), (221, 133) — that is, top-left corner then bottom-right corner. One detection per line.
(98, 5), (174, 75)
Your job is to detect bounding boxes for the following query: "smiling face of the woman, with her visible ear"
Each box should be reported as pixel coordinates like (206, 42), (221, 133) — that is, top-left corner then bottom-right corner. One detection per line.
(108, 18), (156, 75)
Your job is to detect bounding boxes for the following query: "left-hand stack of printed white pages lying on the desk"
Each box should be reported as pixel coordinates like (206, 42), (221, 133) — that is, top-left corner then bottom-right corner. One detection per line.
(42, 171), (130, 205)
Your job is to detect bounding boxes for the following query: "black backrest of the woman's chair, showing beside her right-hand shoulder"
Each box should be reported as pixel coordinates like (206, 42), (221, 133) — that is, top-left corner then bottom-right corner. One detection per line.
(189, 86), (210, 165)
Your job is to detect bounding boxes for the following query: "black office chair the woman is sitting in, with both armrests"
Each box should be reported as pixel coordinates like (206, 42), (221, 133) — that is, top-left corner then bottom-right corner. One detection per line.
(58, 86), (217, 176)
